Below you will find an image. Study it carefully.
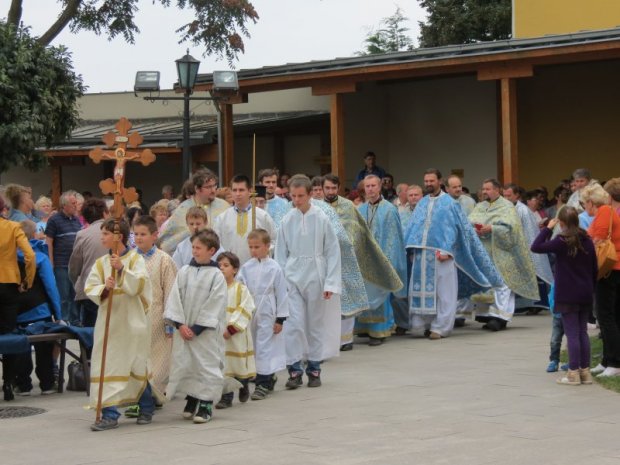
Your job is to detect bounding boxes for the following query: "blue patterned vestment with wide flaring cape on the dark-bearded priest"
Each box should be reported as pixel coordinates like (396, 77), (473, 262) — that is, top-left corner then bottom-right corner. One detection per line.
(405, 194), (503, 315)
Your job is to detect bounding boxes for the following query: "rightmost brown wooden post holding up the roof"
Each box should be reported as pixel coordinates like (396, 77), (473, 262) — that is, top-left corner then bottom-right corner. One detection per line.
(499, 78), (519, 184)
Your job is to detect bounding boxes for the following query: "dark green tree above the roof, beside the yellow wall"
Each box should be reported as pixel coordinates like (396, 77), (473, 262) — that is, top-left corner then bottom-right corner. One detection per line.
(418, 0), (512, 47)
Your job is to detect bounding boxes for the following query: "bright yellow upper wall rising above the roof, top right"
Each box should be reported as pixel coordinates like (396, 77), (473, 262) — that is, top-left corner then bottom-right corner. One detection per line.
(512, 0), (620, 39)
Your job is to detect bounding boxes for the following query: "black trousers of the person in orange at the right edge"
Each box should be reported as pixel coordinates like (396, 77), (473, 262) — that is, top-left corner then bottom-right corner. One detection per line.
(596, 270), (620, 368)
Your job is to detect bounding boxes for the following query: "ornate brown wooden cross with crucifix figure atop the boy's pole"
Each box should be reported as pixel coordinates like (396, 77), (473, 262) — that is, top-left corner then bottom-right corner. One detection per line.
(88, 117), (155, 219)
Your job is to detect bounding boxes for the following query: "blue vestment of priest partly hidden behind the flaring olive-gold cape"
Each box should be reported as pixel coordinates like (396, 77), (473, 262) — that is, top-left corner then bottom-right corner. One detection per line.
(355, 199), (407, 338)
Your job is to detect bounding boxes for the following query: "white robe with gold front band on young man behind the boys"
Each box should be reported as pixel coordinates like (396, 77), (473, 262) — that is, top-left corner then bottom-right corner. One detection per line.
(213, 206), (276, 265)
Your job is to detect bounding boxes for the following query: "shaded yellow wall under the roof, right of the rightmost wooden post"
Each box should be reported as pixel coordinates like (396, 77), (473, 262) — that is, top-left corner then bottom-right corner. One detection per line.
(517, 60), (620, 190)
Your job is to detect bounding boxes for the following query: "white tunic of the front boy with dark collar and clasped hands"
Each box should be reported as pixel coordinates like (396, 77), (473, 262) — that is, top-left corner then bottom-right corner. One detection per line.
(164, 266), (228, 401)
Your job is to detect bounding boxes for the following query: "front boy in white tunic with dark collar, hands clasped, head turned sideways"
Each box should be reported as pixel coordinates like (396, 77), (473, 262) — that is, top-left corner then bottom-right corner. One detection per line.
(164, 231), (228, 423)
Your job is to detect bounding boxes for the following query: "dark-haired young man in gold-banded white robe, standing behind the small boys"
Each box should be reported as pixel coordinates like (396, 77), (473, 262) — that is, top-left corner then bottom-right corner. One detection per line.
(213, 174), (276, 265)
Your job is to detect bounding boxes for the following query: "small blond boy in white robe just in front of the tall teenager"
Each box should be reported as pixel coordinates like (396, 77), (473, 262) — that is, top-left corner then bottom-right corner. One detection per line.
(237, 229), (289, 400)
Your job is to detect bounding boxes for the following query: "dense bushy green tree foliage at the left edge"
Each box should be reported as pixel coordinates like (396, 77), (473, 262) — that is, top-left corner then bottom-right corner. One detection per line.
(0, 21), (84, 173)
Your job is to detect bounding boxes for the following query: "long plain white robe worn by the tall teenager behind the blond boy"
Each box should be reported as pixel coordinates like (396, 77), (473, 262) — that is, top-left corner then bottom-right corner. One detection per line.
(274, 206), (342, 365)
